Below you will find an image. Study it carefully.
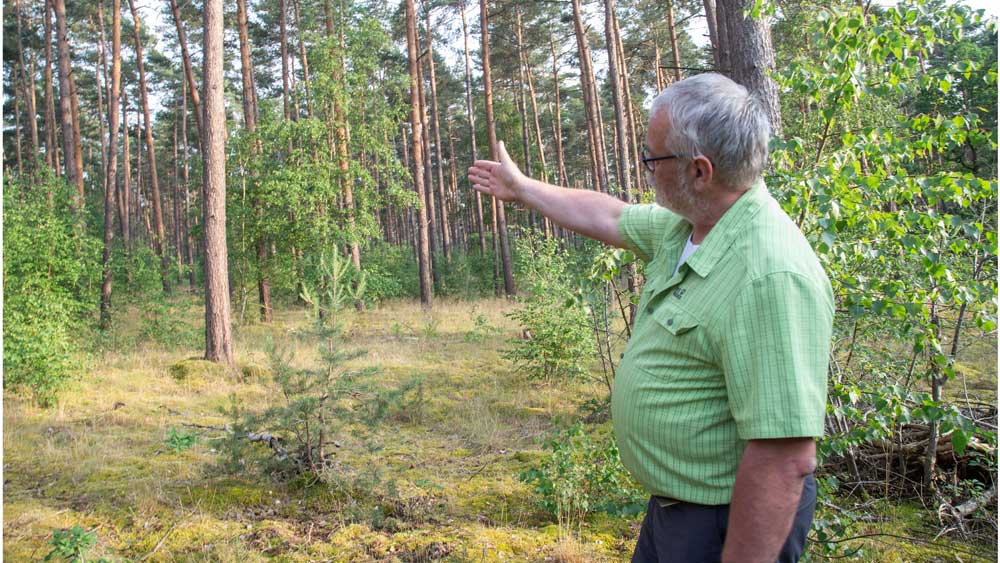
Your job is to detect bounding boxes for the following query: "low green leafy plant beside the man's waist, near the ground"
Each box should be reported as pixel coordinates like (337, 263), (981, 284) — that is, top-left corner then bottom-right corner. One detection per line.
(520, 423), (647, 528)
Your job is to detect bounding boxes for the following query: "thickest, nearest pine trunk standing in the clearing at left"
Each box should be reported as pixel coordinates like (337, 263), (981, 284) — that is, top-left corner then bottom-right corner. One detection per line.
(202, 0), (233, 366)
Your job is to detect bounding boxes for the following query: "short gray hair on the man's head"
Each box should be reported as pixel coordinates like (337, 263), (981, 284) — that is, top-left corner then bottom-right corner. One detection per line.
(649, 73), (771, 190)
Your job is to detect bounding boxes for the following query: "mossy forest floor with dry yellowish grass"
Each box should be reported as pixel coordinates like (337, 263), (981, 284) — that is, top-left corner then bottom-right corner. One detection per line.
(3, 296), (996, 563)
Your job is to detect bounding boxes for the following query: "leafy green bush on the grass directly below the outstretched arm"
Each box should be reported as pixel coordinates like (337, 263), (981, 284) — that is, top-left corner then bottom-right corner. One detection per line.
(504, 231), (594, 381)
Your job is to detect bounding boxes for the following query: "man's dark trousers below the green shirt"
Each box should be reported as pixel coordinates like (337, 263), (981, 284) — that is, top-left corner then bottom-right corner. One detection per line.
(632, 475), (816, 563)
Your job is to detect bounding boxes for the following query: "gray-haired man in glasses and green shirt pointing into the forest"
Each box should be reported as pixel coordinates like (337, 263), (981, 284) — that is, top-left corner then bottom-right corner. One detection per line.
(469, 74), (833, 563)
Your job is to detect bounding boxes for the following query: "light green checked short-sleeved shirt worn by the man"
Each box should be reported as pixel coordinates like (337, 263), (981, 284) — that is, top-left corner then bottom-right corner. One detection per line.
(611, 182), (833, 504)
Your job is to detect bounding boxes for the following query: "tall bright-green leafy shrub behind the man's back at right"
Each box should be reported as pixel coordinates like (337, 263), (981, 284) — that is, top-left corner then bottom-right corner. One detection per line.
(768, 0), (997, 498)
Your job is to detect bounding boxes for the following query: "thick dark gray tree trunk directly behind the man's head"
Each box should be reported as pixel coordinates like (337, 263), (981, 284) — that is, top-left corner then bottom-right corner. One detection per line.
(716, 0), (781, 136)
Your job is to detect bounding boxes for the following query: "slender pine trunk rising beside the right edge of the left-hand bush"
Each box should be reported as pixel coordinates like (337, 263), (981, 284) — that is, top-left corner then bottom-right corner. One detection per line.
(101, 0), (122, 330)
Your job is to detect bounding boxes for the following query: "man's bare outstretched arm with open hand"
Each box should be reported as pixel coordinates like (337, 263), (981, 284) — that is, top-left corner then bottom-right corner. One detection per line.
(469, 142), (628, 247)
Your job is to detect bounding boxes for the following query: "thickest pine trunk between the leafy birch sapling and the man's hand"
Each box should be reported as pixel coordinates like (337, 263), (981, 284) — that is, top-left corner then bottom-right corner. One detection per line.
(404, 0), (434, 308)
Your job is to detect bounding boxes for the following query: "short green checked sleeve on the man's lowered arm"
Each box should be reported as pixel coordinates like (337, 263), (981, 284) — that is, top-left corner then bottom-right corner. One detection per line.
(720, 272), (833, 440)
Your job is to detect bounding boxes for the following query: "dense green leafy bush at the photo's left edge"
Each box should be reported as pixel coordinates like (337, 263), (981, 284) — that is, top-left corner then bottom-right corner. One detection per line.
(3, 171), (100, 406)
